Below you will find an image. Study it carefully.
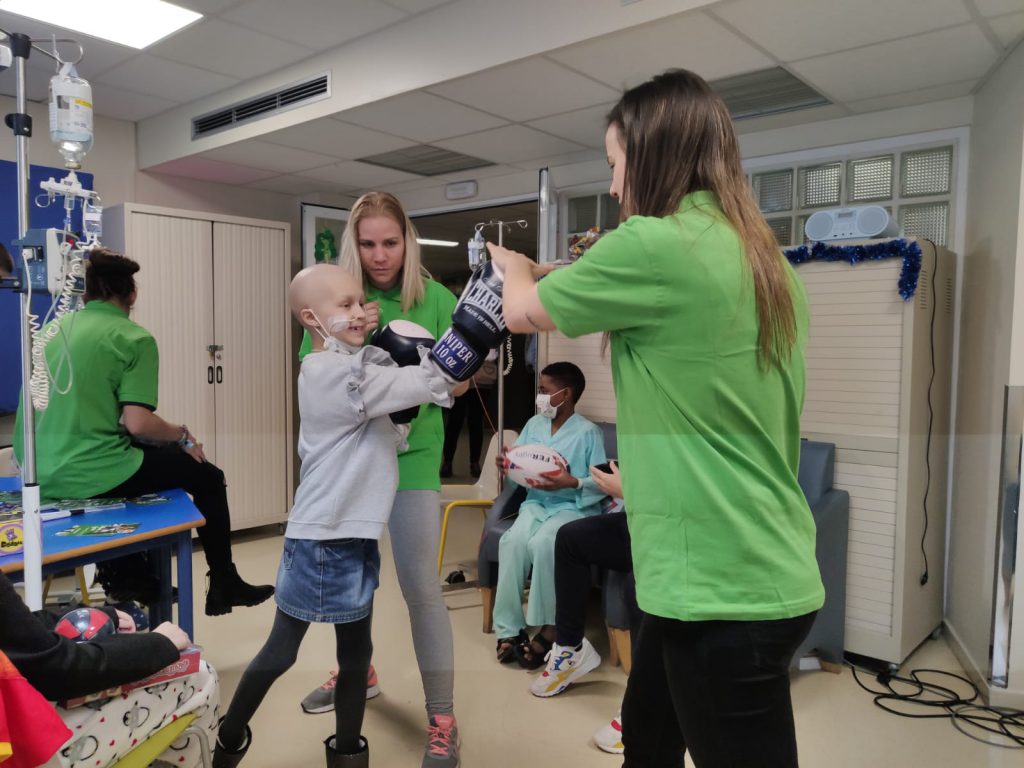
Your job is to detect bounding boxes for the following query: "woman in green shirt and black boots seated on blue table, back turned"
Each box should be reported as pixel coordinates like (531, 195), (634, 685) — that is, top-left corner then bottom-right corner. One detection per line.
(14, 248), (273, 615)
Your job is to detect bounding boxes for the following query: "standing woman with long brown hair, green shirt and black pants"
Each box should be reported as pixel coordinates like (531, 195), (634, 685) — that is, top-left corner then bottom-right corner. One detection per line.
(490, 70), (824, 768)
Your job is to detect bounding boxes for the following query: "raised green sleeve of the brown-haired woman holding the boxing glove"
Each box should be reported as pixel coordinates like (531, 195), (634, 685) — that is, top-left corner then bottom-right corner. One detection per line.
(538, 216), (665, 338)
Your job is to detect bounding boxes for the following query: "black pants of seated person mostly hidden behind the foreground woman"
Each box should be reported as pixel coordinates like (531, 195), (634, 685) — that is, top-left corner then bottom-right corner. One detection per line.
(555, 512), (642, 647)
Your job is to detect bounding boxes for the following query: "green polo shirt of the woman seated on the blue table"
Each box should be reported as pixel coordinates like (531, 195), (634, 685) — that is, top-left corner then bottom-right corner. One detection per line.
(14, 301), (160, 499)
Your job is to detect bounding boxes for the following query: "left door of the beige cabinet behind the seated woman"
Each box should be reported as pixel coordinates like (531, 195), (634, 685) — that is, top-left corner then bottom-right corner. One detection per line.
(125, 212), (217, 462)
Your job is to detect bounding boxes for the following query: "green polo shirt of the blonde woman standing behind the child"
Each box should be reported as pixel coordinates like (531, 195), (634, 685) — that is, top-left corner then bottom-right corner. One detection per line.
(299, 280), (456, 490)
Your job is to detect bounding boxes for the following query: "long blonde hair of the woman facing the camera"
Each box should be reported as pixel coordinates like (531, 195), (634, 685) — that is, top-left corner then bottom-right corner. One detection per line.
(338, 191), (430, 312)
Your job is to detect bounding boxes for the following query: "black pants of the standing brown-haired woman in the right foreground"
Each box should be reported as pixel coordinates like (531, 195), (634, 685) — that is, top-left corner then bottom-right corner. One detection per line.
(623, 612), (815, 768)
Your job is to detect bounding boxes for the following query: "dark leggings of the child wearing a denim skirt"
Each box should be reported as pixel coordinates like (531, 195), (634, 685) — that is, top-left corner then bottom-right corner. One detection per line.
(218, 610), (374, 755)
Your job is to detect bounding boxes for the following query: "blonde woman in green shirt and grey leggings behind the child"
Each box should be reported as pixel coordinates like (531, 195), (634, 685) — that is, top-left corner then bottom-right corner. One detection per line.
(299, 191), (468, 768)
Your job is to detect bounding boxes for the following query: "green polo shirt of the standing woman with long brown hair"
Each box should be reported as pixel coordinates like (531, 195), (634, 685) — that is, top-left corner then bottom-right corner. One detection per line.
(539, 191), (824, 621)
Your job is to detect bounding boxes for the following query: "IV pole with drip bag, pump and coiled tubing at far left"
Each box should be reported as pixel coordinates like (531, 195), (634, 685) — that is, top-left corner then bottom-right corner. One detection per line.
(0, 29), (101, 609)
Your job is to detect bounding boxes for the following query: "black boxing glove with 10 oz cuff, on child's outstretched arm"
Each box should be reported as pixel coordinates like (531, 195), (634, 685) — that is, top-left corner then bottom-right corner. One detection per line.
(430, 261), (509, 381)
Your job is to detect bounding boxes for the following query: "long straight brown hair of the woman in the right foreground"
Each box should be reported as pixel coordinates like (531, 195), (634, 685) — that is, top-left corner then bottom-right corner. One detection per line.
(608, 70), (797, 368)
